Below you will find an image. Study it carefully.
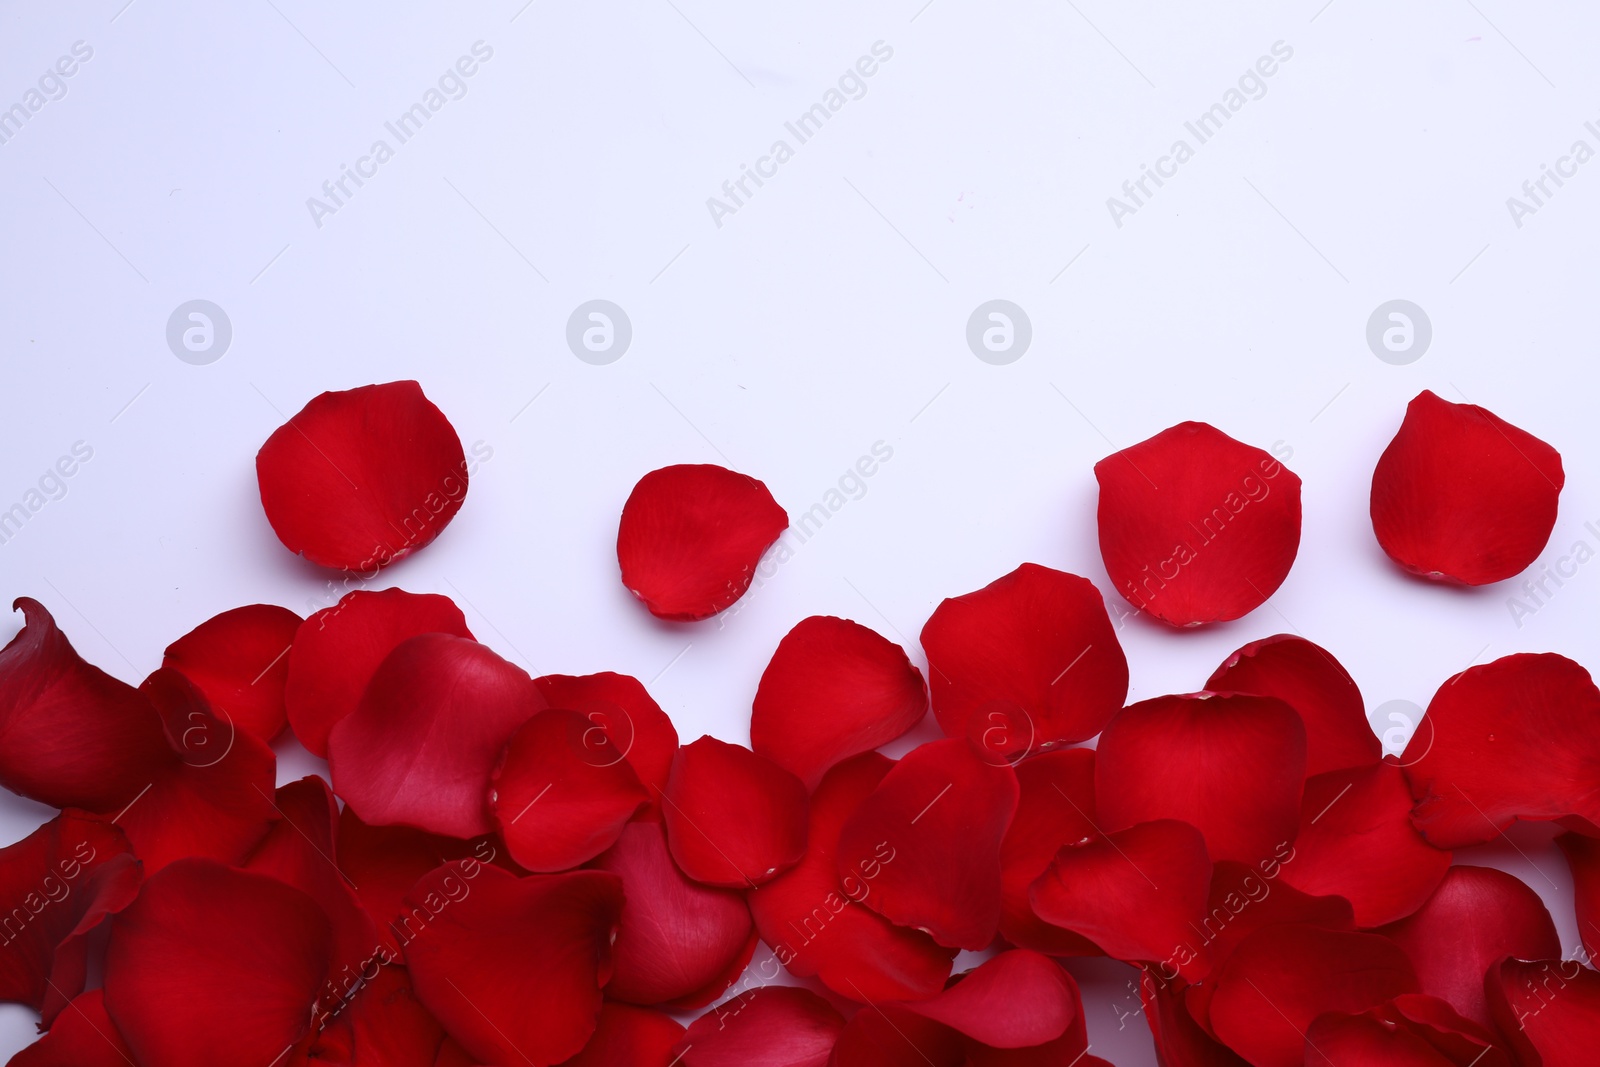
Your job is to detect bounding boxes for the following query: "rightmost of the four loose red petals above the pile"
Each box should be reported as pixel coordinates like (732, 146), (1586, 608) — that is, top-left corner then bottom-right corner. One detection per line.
(1373, 390), (1566, 585)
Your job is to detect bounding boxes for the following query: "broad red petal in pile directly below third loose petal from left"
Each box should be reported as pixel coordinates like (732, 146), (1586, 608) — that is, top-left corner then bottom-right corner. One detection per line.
(1094, 693), (1306, 864)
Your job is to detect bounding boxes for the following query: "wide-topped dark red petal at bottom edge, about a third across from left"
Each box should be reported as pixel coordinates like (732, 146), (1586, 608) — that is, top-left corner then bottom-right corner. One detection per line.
(405, 859), (622, 1064)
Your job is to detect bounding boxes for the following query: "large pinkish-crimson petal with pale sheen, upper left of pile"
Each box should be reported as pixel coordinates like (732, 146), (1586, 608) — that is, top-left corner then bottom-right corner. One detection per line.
(328, 633), (544, 837)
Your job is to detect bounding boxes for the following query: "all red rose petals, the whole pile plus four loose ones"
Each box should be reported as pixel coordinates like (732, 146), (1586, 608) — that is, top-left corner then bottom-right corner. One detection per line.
(0, 382), (1600, 1067)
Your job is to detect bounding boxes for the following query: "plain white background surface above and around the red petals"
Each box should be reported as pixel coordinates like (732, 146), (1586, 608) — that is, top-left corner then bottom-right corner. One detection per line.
(0, 0), (1600, 1067)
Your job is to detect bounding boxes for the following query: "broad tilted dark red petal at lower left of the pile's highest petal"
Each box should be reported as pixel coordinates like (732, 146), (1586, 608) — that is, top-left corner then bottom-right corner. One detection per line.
(838, 737), (1019, 949)
